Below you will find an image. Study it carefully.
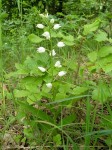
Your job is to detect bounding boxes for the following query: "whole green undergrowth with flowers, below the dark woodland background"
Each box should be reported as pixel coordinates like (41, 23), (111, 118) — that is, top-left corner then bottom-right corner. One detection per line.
(0, 5), (112, 150)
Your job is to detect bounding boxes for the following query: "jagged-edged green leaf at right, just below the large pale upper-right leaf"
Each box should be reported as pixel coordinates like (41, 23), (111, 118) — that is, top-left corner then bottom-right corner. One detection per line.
(95, 31), (108, 42)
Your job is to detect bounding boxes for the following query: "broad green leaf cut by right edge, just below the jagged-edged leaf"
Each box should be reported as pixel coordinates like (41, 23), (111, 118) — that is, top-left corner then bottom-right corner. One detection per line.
(98, 46), (112, 57)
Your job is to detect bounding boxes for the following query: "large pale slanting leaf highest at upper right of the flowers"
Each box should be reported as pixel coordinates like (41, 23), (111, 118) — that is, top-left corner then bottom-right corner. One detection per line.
(83, 20), (100, 35)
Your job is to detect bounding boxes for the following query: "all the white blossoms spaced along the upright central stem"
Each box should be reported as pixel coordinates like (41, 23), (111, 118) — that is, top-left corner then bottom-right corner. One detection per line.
(36, 14), (67, 89)
